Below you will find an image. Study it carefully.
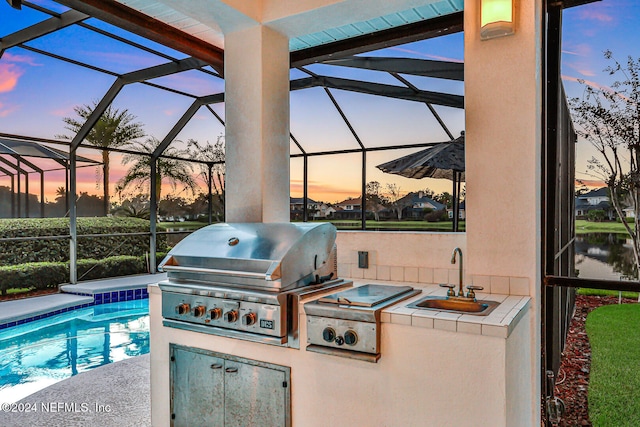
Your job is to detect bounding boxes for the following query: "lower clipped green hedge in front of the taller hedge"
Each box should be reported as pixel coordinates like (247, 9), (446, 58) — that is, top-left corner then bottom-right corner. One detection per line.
(0, 254), (163, 295)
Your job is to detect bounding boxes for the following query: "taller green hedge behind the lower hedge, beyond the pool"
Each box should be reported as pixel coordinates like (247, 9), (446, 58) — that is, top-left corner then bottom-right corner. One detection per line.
(0, 217), (167, 266)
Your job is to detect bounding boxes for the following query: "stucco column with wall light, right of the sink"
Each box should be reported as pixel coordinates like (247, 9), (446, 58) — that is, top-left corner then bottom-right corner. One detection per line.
(464, 0), (542, 426)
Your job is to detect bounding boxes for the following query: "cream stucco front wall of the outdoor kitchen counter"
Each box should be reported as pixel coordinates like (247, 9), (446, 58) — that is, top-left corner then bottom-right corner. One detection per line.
(150, 286), (529, 427)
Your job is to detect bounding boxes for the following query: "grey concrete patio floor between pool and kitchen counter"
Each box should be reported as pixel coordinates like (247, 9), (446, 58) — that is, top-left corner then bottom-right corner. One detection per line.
(0, 354), (151, 427)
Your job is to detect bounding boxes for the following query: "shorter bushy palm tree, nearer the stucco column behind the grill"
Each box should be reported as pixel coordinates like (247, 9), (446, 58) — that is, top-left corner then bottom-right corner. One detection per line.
(116, 137), (198, 203)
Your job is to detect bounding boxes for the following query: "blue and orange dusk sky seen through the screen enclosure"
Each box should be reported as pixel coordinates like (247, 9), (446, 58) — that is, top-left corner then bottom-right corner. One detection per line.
(0, 0), (640, 202)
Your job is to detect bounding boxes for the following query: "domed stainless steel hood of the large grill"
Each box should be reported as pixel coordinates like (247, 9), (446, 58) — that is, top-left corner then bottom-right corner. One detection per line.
(158, 223), (336, 292)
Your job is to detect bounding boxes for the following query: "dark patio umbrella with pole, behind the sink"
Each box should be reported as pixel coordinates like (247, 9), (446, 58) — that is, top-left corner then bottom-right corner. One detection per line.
(376, 132), (465, 231)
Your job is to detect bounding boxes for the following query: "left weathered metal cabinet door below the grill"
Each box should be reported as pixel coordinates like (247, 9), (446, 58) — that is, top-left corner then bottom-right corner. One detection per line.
(171, 347), (225, 427)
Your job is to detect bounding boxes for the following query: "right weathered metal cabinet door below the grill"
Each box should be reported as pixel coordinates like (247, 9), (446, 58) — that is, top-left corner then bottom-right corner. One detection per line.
(224, 360), (288, 427)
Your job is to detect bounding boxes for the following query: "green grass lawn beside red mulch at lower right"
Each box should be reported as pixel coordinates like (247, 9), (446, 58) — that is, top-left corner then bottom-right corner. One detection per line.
(586, 304), (640, 427)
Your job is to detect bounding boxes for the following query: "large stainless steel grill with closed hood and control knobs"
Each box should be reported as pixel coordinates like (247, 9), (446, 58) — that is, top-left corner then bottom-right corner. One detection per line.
(159, 223), (351, 347)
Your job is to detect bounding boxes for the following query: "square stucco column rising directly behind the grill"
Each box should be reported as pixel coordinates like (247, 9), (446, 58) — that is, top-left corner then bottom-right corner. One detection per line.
(225, 26), (289, 222)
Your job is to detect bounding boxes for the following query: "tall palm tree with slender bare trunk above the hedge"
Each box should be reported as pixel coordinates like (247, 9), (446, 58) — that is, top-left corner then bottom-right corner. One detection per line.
(60, 102), (145, 215)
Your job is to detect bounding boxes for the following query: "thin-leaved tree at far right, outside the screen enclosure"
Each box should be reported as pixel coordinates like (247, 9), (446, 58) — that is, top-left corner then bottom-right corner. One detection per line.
(570, 51), (640, 278)
